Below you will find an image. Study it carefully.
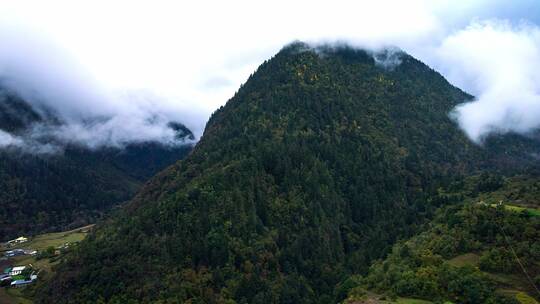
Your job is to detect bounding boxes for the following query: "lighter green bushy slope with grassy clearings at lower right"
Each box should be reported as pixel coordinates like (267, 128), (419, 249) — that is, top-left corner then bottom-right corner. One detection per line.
(354, 175), (540, 303)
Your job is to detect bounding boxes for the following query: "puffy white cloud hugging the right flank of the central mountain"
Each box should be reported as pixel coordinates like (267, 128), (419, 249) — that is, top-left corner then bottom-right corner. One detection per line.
(436, 20), (540, 142)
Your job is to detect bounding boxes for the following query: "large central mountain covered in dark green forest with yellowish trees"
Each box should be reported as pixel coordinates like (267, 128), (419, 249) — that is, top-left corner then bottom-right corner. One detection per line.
(36, 43), (540, 303)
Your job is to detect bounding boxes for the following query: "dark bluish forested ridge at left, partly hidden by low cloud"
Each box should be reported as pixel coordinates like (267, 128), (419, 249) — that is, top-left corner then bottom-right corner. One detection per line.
(0, 89), (193, 241)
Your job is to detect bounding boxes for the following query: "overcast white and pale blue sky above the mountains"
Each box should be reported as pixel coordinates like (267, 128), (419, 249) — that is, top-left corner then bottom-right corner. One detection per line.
(0, 0), (540, 150)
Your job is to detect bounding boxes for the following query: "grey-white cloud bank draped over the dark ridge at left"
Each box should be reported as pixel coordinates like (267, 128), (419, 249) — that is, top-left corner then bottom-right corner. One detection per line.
(0, 29), (200, 153)
